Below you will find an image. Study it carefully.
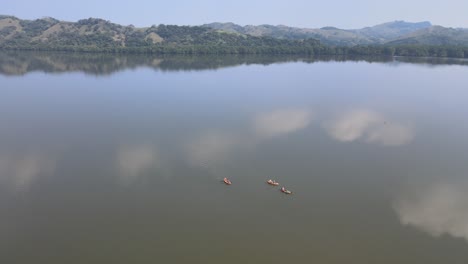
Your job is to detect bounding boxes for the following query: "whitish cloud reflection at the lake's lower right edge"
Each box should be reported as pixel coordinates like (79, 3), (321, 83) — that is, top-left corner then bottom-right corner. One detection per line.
(393, 183), (468, 240)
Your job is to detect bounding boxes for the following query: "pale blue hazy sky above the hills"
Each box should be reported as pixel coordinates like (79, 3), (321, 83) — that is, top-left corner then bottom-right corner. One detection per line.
(0, 0), (468, 28)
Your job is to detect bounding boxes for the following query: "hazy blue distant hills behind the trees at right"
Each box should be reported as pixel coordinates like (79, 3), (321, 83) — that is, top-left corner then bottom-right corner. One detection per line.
(204, 21), (468, 47)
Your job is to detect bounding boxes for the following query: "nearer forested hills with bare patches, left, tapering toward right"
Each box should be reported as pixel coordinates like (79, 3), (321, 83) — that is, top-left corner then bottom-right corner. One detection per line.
(0, 16), (320, 53)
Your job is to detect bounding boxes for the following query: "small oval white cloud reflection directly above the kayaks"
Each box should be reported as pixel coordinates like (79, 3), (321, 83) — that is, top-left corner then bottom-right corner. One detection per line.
(254, 109), (313, 138)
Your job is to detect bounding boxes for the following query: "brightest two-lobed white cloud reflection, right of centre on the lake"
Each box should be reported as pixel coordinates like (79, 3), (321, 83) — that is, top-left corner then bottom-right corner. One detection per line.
(325, 109), (414, 146)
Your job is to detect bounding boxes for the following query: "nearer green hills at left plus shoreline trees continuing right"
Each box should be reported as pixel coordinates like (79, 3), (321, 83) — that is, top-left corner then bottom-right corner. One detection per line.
(0, 16), (468, 58)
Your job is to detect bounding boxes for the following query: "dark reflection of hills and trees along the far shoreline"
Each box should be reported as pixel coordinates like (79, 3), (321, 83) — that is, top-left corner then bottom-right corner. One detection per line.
(5, 51), (468, 76)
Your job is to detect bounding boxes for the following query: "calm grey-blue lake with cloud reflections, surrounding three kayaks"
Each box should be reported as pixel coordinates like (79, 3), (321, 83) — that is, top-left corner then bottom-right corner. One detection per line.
(0, 52), (468, 264)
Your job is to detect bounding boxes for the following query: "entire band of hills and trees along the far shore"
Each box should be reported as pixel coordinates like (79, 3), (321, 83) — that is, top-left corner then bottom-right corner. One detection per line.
(0, 15), (468, 58)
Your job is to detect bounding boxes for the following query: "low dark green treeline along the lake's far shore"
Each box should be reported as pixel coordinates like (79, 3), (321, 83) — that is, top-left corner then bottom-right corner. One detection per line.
(0, 39), (468, 58)
